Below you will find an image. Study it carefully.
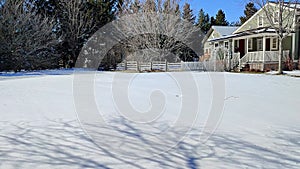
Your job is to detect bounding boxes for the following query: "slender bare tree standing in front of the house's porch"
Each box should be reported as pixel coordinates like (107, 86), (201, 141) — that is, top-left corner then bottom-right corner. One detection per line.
(252, 0), (300, 74)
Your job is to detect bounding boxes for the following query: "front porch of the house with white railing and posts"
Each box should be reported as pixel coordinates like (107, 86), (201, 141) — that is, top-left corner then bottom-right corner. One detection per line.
(233, 33), (294, 71)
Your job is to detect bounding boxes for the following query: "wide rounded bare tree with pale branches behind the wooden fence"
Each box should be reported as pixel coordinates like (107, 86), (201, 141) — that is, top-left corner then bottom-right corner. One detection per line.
(115, 0), (201, 62)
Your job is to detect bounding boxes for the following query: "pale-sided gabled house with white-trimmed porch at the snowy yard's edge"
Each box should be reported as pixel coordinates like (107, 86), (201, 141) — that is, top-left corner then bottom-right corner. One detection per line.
(203, 3), (300, 71)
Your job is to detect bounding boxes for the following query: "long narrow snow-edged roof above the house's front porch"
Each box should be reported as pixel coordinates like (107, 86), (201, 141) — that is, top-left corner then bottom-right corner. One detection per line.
(208, 27), (276, 42)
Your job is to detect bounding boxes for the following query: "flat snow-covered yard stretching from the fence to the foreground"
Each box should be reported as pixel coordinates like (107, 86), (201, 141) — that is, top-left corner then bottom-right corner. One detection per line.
(0, 71), (300, 169)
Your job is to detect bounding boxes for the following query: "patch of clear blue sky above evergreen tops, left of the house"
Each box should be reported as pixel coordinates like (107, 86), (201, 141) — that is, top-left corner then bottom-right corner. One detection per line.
(187, 0), (249, 22)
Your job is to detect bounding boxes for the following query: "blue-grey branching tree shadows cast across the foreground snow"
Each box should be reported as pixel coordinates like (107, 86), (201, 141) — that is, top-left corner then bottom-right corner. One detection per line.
(0, 119), (300, 169)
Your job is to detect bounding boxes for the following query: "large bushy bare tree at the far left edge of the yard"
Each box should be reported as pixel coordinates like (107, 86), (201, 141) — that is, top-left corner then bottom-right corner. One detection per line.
(0, 0), (59, 71)
